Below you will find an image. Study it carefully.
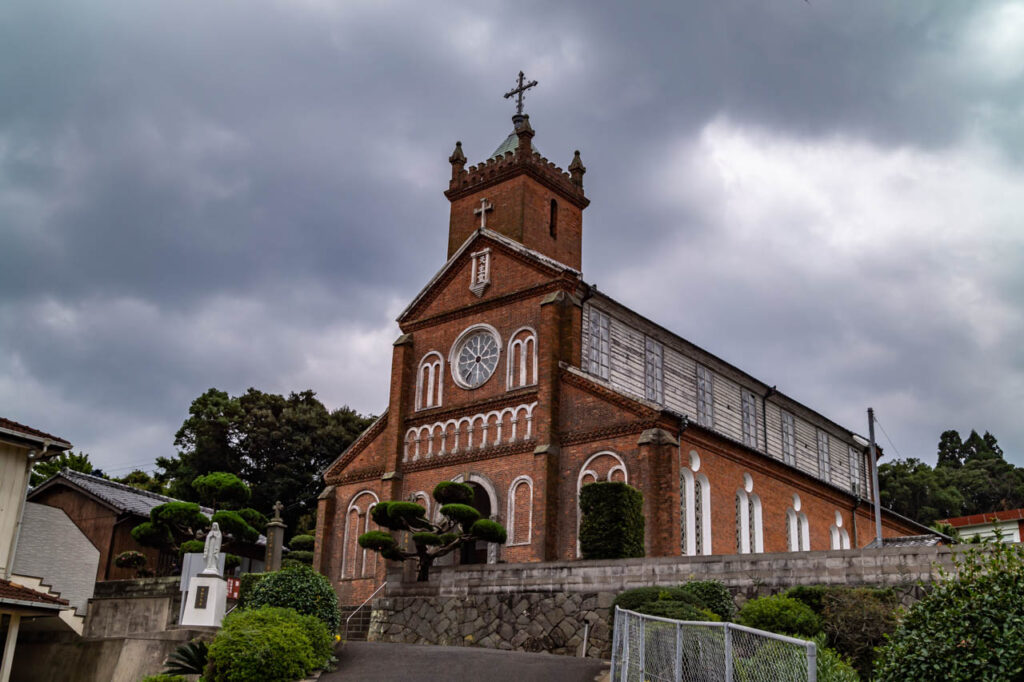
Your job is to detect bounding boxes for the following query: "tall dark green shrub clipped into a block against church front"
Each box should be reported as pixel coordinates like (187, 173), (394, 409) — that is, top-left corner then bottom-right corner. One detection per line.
(580, 481), (644, 559)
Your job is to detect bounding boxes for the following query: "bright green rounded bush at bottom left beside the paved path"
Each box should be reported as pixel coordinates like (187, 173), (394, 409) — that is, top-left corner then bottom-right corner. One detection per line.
(203, 606), (331, 682)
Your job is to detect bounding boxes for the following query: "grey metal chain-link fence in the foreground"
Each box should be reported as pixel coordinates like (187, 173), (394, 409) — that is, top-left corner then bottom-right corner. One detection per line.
(611, 606), (817, 682)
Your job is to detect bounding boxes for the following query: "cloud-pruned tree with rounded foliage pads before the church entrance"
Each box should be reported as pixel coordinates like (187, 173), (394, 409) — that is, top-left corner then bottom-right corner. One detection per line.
(358, 481), (507, 583)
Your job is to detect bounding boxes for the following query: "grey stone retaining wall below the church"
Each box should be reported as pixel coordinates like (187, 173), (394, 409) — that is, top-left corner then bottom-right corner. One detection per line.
(370, 547), (962, 657)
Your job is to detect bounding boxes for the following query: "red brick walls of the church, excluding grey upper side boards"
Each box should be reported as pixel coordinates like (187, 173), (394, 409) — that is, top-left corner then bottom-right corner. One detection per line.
(314, 114), (921, 605)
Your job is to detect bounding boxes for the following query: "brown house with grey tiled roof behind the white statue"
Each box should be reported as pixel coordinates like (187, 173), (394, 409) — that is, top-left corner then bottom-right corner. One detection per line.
(29, 469), (265, 581)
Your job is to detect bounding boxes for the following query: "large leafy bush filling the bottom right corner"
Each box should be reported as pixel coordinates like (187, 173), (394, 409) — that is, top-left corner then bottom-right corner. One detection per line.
(876, 543), (1024, 682)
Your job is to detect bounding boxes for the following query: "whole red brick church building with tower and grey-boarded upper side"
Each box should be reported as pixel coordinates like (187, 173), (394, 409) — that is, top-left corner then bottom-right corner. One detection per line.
(314, 84), (923, 604)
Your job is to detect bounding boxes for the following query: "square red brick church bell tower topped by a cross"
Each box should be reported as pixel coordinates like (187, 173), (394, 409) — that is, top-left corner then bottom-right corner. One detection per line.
(444, 72), (590, 270)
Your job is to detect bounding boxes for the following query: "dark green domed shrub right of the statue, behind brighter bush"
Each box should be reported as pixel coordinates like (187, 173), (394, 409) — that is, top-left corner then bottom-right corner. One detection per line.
(246, 564), (341, 633)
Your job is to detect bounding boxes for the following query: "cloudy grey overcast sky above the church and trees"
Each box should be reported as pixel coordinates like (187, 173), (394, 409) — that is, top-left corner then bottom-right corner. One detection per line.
(0, 0), (1024, 475)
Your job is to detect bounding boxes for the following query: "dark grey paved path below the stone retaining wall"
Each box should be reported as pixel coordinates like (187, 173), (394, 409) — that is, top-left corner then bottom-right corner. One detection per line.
(319, 642), (608, 682)
